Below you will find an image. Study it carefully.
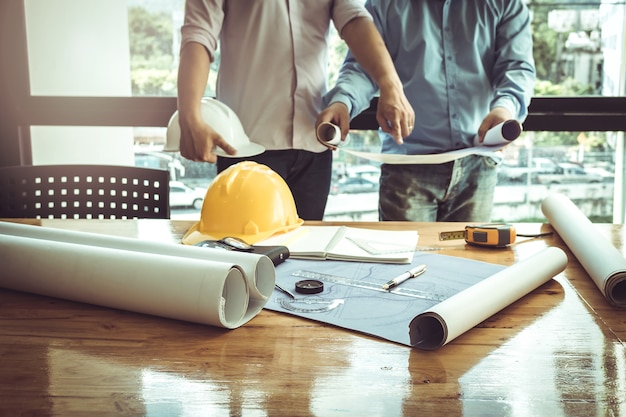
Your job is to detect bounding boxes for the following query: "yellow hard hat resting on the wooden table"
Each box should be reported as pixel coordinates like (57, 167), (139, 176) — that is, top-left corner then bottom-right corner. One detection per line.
(183, 161), (304, 245)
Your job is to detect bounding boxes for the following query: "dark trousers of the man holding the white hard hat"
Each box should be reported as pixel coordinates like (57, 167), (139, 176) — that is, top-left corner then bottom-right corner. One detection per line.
(217, 149), (333, 220)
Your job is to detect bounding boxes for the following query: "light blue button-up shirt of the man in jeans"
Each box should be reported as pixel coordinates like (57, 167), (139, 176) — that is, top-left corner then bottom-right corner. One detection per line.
(324, 0), (535, 155)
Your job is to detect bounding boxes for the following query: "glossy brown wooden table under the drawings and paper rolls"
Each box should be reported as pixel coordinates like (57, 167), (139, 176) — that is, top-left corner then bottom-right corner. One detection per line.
(0, 220), (626, 417)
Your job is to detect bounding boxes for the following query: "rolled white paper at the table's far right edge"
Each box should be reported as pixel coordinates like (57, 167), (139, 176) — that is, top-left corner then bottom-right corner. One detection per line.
(541, 193), (626, 308)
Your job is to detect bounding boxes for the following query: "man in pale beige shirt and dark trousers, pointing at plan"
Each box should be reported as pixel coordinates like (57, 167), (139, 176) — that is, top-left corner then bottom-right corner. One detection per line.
(178, 0), (414, 220)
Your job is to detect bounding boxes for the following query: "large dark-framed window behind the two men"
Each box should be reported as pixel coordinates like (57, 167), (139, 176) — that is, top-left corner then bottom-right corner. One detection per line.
(0, 0), (626, 222)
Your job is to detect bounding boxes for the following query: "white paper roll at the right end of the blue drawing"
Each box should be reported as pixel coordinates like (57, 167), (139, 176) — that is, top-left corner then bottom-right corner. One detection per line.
(409, 247), (567, 350)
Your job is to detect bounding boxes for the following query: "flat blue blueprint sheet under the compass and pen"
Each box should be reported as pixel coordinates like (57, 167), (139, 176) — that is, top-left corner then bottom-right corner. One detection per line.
(265, 252), (505, 346)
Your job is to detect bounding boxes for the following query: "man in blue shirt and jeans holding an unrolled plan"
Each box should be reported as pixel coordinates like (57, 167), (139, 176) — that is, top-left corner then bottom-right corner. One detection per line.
(318, 0), (535, 222)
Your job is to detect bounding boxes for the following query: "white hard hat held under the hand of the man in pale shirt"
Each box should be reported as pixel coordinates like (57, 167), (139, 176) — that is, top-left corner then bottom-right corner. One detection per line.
(163, 98), (265, 158)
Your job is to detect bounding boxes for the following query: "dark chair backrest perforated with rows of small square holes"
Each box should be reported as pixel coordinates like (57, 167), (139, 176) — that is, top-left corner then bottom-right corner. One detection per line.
(0, 165), (170, 219)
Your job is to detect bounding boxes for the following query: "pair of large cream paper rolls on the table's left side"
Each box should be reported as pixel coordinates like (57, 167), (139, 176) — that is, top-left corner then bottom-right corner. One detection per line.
(0, 222), (275, 329)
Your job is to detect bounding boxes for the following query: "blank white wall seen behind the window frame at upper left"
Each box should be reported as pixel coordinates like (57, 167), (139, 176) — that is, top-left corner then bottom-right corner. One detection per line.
(25, 0), (134, 165)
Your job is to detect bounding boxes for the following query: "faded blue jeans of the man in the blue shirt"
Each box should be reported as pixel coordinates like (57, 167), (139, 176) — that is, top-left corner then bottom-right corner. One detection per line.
(378, 155), (498, 222)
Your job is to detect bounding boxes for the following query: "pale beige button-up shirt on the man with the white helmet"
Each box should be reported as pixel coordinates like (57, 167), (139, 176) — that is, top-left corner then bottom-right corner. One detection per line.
(181, 0), (371, 152)
